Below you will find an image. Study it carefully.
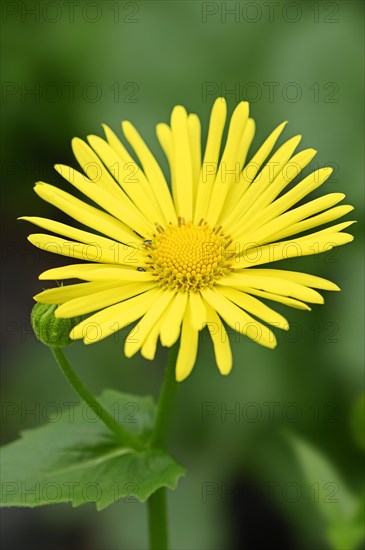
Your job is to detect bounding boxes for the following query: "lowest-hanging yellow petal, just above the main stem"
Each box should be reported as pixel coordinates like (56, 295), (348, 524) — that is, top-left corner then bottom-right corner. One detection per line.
(176, 308), (199, 382)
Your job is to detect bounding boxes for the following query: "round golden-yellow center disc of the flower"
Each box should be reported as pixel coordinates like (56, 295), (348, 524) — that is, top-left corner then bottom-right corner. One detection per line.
(147, 218), (233, 292)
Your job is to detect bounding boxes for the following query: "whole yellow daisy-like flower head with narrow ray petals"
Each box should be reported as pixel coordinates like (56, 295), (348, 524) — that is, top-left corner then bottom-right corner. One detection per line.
(22, 98), (353, 381)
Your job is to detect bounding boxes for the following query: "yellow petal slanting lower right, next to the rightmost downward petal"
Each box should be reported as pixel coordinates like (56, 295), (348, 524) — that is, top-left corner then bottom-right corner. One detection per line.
(202, 288), (276, 348)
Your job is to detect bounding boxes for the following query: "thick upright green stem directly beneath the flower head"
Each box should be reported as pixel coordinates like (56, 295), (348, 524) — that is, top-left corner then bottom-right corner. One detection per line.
(148, 341), (180, 550)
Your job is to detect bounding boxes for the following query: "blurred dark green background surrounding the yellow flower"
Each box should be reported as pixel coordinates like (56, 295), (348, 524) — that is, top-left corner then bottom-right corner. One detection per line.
(1, 1), (364, 550)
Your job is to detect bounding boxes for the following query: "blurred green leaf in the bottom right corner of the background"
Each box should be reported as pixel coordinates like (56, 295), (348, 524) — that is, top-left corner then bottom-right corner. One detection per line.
(288, 434), (364, 549)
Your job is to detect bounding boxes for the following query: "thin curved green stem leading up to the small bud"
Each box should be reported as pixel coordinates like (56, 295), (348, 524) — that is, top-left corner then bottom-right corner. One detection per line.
(51, 347), (143, 450)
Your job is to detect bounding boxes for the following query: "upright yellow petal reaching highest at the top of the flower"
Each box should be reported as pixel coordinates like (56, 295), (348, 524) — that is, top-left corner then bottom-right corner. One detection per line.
(194, 97), (227, 223)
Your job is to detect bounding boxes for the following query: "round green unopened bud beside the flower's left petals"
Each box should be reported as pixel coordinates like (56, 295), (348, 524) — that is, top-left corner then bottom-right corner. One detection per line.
(31, 302), (82, 348)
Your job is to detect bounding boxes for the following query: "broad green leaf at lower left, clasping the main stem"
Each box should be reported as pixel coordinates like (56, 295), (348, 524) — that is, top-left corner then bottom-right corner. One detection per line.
(0, 390), (185, 510)
